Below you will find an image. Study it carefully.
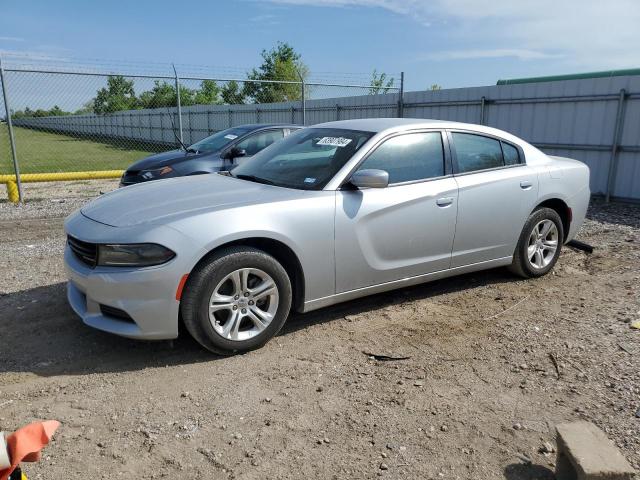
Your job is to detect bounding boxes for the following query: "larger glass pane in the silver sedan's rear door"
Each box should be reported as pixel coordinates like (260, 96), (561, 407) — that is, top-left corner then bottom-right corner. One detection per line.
(452, 132), (504, 173)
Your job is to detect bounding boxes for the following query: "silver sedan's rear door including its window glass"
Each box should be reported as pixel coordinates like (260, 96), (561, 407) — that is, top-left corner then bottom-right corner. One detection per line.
(448, 131), (538, 268)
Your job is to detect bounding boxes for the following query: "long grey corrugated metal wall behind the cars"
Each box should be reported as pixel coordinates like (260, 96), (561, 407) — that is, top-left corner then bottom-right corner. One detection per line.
(15, 76), (640, 200)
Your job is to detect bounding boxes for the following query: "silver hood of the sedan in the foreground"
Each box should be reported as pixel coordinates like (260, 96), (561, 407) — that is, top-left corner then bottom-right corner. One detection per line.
(80, 173), (304, 227)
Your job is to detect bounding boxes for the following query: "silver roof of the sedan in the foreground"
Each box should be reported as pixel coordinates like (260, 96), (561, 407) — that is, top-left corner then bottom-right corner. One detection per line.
(313, 118), (523, 142)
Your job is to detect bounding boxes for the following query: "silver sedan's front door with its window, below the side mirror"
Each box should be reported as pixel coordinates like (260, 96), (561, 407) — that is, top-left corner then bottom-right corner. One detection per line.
(335, 131), (458, 293)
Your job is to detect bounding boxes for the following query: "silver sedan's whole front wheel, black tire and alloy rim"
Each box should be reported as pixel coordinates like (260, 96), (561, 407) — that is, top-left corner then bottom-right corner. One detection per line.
(180, 247), (292, 355)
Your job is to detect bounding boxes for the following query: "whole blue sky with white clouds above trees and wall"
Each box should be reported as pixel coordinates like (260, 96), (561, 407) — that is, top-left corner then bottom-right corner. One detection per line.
(0, 0), (640, 90)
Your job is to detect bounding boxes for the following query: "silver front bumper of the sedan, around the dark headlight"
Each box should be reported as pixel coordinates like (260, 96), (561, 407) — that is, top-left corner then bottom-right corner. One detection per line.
(64, 213), (204, 340)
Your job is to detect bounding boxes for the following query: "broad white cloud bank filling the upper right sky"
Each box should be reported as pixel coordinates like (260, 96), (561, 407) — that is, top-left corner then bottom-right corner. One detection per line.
(260, 0), (640, 68)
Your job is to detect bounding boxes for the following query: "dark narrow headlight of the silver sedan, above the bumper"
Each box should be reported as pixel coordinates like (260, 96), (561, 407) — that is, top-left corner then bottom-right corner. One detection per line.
(98, 243), (176, 267)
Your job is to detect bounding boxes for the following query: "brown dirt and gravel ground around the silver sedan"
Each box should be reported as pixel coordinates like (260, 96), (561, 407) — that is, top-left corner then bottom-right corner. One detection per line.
(0, 182), (640, 480)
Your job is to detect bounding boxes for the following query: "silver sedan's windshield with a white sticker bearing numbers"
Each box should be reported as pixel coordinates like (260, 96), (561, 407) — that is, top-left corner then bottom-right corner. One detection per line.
(231, 128), (373, 190)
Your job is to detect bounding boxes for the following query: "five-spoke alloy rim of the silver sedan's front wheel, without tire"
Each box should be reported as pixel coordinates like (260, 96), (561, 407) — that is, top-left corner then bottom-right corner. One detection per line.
(209, 268), (279, 341)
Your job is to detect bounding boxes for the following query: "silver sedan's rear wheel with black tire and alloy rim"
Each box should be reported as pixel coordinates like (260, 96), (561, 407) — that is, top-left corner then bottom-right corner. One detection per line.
(509, 207), (564, 278)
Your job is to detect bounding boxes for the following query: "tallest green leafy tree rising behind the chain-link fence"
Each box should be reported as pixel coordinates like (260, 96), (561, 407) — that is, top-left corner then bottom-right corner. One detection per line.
(242, 42), (309, 103)
